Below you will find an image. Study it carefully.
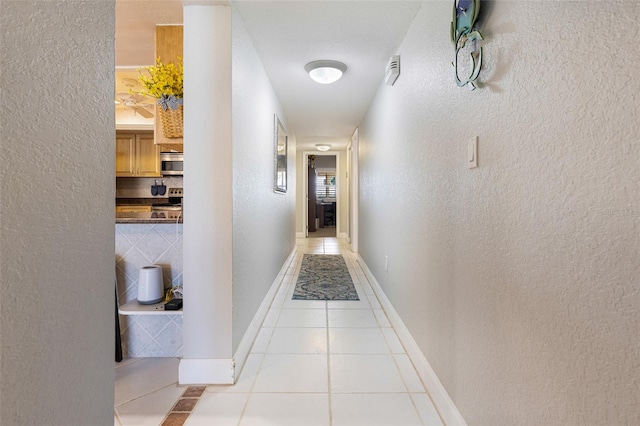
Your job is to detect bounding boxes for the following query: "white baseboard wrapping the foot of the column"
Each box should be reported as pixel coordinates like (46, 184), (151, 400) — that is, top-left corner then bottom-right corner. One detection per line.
(178, 358), (235, 385)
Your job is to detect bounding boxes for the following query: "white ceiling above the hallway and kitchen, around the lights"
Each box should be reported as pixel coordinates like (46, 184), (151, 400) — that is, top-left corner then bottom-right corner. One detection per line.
(116, 0), (421, 150)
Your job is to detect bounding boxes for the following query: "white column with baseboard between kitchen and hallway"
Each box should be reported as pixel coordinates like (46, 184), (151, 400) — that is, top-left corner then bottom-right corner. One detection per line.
(179, 1), (235, 384)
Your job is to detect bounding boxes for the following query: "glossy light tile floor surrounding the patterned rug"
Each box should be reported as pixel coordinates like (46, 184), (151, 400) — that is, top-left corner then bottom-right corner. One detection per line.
(114, 238), (442, 426)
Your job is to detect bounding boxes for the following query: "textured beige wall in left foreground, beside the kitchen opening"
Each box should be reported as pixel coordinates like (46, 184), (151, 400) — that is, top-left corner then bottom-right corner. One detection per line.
(0, 0), (115, 425)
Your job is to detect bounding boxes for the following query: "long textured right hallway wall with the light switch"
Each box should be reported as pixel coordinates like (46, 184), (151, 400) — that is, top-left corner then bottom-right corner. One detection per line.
(360, 1), (640, 425)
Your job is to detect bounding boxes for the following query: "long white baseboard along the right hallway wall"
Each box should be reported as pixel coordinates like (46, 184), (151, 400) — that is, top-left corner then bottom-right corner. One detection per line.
(358, 255), (467, 426)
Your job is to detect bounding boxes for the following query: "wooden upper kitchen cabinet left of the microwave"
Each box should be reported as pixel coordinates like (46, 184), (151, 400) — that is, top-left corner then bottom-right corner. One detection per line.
(116, 131), (162, 177)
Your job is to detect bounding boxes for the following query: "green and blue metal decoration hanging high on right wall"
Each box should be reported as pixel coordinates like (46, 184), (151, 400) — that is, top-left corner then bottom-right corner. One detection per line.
(451, 0), (482, 90)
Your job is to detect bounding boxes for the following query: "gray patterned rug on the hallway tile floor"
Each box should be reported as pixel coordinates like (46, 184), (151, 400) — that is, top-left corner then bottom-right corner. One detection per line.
(292, 254), (360, 300)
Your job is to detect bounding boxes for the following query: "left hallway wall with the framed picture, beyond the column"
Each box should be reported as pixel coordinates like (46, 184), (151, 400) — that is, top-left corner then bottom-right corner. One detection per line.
(233, 10), (296, 351)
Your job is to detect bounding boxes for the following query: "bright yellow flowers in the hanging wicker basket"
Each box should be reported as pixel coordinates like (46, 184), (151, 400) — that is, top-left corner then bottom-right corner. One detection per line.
(138, 58), (184, 110)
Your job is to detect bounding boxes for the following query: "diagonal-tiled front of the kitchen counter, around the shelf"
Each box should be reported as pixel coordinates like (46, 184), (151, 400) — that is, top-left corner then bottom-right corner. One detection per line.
(115, 224), (182, 358)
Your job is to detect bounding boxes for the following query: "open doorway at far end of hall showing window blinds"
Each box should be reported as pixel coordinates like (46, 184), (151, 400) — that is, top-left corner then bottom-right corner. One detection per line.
(307, 153), (339, 238)
